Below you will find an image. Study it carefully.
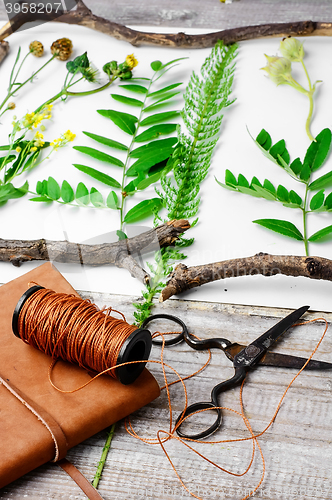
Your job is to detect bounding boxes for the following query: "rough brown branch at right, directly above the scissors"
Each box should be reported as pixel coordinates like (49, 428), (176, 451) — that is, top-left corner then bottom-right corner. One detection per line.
(159, 253), (332, 302)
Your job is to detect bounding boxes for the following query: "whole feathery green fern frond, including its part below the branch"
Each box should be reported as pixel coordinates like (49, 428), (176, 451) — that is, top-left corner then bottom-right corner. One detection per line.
(134, 42), (237, 324)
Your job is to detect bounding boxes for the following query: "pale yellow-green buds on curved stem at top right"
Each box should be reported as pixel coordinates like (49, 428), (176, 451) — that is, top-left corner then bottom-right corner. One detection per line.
(261, 37), (319, 141)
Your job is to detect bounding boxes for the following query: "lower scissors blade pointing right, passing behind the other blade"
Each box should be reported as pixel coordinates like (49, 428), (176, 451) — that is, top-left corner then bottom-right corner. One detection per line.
(225, 344), (332, 370)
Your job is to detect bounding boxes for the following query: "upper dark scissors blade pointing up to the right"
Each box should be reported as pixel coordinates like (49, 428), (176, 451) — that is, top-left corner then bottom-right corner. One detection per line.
(233, 306), (309, 369)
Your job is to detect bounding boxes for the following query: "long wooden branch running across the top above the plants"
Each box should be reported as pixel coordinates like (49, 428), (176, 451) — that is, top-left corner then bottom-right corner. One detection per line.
(0, 0), (332, 48)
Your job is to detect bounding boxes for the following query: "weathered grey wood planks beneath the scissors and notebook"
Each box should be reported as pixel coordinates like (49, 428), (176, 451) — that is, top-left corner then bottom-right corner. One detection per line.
(0, 294), (332, 500)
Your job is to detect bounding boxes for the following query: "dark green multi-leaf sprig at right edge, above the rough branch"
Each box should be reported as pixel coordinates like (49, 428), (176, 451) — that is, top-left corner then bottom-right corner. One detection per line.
(217, 128), (332, 255)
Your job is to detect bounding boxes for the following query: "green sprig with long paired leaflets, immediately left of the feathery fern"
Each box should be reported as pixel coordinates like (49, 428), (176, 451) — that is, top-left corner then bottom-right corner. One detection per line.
(64, 58), (182, 235)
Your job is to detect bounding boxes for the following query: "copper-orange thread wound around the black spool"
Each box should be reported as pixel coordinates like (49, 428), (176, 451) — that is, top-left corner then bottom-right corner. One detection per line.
(17, 288), (137, 378)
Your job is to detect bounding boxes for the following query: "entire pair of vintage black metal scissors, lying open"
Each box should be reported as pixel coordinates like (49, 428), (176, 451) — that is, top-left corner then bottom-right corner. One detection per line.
(142, 306), (332, 439)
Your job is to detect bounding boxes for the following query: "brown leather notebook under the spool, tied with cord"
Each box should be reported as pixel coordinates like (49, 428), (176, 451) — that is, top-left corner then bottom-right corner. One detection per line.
(0, 263), (160, 488)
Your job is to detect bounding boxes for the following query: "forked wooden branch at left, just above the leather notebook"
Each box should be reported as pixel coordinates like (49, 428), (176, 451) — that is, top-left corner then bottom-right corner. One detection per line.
(0, 219), (190, 283)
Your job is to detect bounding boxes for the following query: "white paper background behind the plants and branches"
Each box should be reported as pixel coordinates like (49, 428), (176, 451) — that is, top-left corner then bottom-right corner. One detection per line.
(0, 23), (332, 311)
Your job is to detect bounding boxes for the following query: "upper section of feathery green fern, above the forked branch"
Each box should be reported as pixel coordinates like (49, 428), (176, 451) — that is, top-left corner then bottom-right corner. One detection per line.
(161, 41), (237, 219)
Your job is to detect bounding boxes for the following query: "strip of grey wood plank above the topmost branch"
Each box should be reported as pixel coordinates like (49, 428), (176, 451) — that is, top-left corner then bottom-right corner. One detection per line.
(0, 0), (332, 29)
